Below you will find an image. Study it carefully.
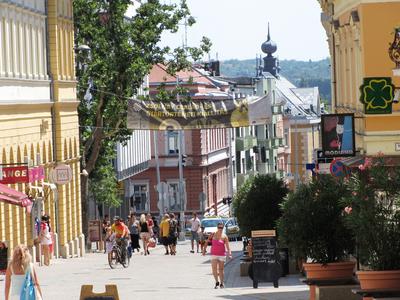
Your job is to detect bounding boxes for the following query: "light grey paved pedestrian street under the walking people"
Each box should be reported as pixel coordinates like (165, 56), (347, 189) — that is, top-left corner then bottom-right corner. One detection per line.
(0, 242), (308, 300)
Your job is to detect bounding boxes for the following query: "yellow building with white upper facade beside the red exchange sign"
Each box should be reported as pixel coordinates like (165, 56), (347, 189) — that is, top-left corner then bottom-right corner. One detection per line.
(0, 0), (84, 257)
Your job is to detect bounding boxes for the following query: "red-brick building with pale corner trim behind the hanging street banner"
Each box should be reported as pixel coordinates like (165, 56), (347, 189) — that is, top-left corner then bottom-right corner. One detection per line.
(129, 65), (232, 215)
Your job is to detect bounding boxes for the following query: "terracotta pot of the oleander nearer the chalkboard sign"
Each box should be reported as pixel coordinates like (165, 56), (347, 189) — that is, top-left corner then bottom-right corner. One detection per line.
(303, 261), (356, 300)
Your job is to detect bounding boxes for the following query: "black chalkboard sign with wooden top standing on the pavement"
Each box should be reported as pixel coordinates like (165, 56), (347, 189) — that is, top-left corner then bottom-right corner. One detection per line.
(249, 230), (282, 288)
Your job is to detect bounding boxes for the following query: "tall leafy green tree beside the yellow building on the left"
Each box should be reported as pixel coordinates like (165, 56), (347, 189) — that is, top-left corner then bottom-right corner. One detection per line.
(74, 0), (210, 237)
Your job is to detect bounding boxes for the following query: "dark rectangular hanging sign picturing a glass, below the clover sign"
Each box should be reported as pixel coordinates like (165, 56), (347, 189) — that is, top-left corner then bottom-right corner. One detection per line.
(321, 114), (356, 157)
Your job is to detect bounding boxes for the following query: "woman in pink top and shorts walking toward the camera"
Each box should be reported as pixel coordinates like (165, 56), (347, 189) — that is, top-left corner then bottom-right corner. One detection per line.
(203, 222), (232, 289)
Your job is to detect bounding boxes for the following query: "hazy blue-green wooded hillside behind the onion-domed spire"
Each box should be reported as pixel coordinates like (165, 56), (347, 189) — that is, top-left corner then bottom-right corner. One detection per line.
(221, 58), (331, 103)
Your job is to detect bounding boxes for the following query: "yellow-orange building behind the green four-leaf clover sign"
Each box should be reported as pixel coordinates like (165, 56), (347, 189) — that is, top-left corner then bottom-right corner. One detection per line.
(319, 0), (400, 155)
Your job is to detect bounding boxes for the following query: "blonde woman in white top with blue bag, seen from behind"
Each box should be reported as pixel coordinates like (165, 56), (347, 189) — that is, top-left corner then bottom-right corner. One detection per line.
(5, 245), (42, 300)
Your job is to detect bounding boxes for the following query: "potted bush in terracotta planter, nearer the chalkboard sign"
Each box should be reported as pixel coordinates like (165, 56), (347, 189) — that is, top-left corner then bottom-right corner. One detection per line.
(278, 175), (355, 299)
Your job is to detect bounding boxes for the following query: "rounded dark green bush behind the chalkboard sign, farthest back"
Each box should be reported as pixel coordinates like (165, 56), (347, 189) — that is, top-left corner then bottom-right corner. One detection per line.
(233, 174), (288, 237)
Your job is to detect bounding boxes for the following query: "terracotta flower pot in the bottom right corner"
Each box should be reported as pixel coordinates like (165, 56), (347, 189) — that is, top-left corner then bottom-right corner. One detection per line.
(357, 270), (400, 300)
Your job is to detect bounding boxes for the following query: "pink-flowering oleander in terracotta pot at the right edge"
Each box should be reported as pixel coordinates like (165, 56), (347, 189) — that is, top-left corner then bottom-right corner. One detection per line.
(343, 154), (400, 289)
